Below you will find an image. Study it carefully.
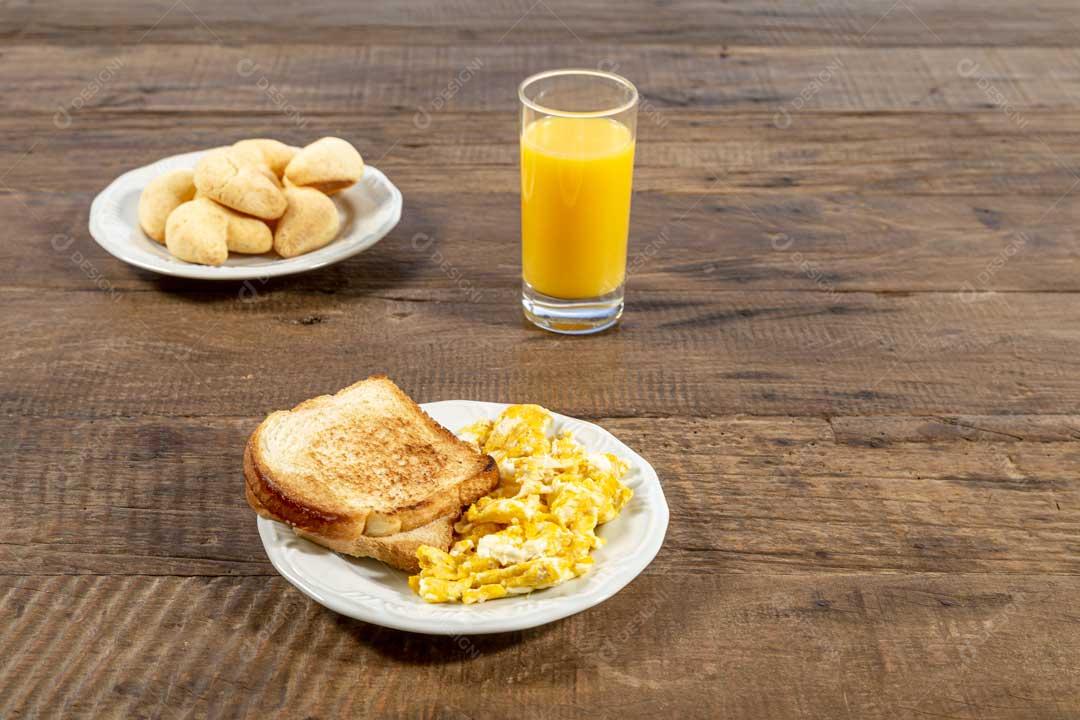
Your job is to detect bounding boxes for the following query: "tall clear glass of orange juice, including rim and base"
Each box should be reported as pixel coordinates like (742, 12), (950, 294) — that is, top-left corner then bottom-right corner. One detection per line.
(517, 70), (637, 335)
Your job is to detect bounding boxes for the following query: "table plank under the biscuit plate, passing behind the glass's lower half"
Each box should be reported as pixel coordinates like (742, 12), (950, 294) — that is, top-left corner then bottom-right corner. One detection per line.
(0, 187), (1080, 299)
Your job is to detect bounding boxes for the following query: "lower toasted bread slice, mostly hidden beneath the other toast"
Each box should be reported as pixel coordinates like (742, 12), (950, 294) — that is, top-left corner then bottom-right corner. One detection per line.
(244, 468), (457, 573)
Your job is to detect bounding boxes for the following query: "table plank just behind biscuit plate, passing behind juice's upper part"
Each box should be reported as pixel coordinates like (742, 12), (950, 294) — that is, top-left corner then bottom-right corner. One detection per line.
(8, 111), (1080, 198)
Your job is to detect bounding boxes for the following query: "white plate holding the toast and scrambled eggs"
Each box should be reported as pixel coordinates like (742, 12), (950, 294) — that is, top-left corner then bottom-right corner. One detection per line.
(258, 400), (667, 635)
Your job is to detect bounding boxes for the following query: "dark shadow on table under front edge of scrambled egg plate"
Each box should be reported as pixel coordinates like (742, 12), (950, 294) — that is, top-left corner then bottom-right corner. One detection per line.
(323, 608), (562, 665)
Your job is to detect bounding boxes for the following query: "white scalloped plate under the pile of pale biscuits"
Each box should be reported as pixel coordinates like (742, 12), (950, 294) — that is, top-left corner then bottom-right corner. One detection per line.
(90, 150), (402, 280)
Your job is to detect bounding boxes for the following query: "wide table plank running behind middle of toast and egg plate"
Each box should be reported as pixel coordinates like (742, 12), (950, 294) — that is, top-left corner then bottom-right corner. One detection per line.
(0, 416), (1080, 578)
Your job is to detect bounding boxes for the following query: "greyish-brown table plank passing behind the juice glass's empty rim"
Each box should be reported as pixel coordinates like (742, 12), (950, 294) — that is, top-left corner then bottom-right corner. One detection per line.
(8, 44), (1080, 118)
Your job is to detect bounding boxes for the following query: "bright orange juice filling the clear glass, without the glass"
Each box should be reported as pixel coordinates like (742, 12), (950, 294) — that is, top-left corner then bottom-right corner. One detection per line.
(522, 117), (634, 299)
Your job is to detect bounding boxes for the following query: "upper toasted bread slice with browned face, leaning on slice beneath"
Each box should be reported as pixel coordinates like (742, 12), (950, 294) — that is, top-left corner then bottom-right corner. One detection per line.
(244, 376), (499, 543)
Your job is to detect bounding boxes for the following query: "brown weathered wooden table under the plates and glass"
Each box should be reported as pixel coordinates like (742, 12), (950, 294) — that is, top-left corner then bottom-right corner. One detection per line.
(0, 0), (1080, 719)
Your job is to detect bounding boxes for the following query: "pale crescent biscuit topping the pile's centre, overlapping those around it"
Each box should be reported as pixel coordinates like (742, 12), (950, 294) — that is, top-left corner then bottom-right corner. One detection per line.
(194, 148), (286, 220)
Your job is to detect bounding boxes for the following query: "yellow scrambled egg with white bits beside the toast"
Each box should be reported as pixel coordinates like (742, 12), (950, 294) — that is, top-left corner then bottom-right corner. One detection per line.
(408, 405), (633, 603)
